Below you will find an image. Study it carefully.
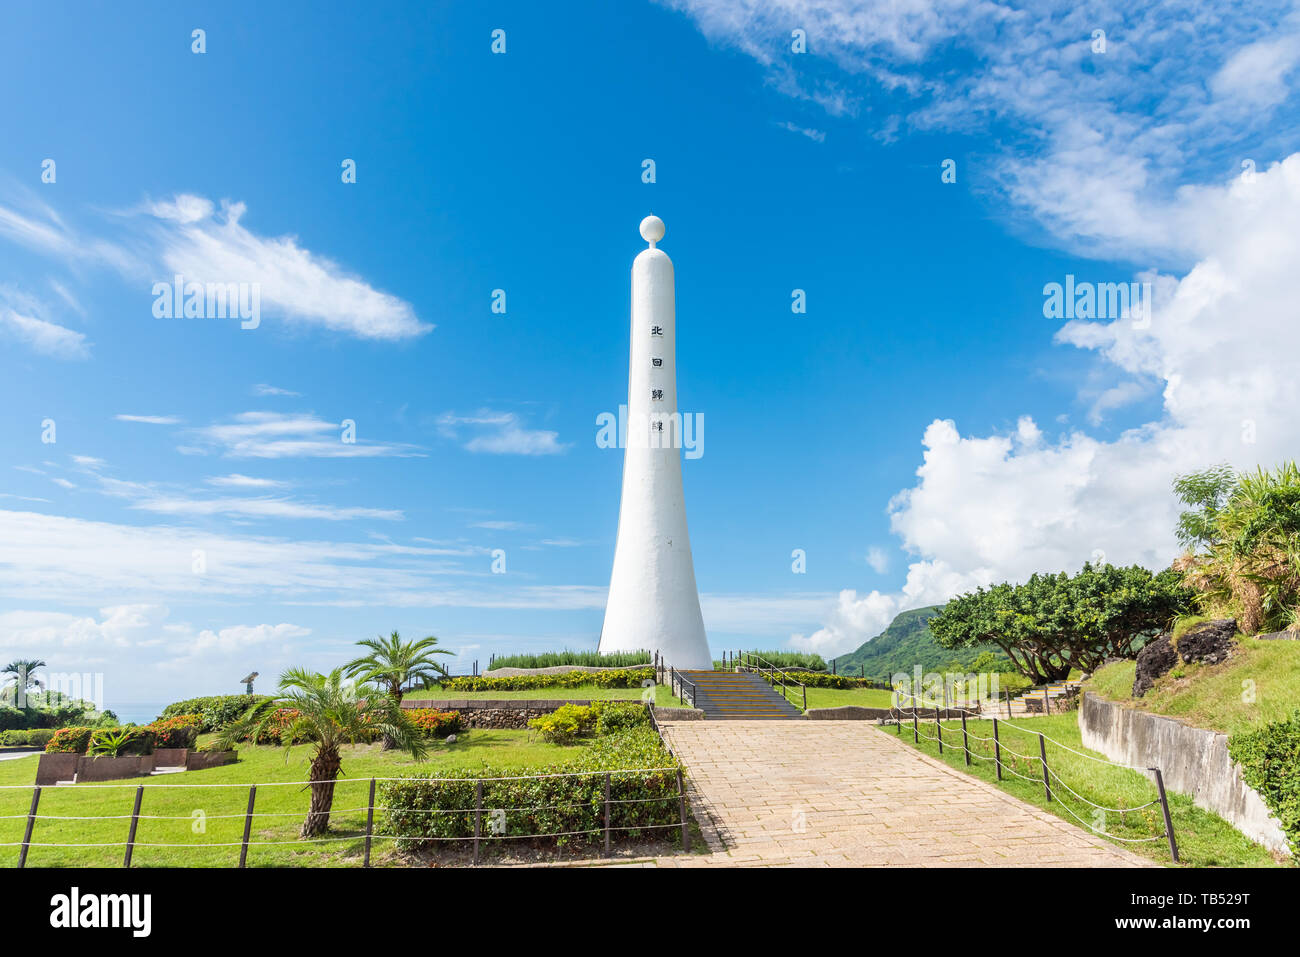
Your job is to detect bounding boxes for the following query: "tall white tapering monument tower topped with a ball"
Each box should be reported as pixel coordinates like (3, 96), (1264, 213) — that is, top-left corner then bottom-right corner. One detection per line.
(601, 216), (714, 671)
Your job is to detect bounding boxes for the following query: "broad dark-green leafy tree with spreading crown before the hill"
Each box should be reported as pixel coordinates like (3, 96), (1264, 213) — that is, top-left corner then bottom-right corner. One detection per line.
(930, 563), (1191, 684)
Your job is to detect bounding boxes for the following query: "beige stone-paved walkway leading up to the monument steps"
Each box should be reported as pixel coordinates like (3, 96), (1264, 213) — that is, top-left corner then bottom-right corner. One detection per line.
(644, 720), (1154, 867)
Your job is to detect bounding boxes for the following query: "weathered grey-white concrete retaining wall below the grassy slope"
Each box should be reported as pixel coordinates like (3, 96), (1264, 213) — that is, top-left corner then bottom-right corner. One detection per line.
(1079, 693), (1290, 853)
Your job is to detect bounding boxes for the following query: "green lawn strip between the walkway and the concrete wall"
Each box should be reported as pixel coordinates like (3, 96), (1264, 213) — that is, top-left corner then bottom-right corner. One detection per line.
(881, 713), (1278, 867)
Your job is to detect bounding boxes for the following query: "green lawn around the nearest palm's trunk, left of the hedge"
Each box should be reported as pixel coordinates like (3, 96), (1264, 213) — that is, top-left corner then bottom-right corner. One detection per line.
(0, 731), (595, 867)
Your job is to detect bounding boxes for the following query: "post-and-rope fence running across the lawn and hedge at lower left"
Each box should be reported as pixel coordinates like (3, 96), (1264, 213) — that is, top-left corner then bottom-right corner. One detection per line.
(0, 767), (690, 867)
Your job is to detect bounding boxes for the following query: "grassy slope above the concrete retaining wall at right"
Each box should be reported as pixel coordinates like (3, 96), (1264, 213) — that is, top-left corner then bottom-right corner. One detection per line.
(1084, 638), (1300, 735)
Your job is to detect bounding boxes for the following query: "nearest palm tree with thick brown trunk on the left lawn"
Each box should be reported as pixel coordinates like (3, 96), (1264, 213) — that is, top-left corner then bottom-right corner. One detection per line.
(218, 668), (425, 837)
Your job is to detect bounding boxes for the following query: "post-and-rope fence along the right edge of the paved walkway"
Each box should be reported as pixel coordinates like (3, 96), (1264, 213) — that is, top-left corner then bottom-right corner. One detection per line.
(893, 692), (1179, 863)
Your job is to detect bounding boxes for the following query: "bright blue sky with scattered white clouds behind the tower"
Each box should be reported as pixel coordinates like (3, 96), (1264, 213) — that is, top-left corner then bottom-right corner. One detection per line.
(0, 0), (1300, 705)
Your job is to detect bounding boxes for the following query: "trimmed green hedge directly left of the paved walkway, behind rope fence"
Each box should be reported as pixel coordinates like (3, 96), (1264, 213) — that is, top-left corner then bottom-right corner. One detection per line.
(377, 727), (681, 850)
